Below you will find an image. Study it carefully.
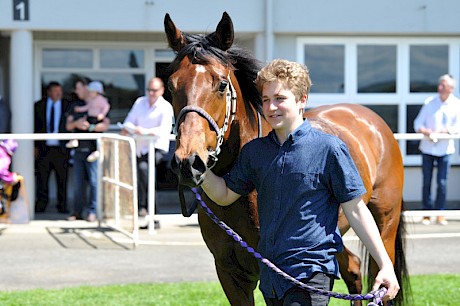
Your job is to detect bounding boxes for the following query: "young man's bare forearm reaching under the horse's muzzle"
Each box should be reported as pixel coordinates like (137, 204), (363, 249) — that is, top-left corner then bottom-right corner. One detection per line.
(201, 169), (241, 206)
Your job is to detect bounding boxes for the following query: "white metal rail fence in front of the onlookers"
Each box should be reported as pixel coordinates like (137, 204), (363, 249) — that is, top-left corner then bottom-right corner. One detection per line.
(0, 133), (460, 237)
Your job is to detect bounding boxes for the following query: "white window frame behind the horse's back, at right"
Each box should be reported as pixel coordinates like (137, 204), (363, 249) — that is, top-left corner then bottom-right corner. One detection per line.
(296, 36), (460, 166)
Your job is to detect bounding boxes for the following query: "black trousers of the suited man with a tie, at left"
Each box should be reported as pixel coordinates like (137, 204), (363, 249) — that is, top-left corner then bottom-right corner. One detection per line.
(35, 146), (69, 212)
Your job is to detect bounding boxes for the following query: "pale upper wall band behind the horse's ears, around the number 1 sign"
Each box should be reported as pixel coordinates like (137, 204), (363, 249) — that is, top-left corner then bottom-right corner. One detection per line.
(0, 0), (264, 32)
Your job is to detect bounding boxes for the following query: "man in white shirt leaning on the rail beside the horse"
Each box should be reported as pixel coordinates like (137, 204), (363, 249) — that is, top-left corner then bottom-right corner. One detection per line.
(121, 78), (174, 220)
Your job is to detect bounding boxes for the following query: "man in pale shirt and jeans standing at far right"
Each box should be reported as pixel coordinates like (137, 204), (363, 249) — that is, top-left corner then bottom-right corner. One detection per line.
(414, 74), (460, 225)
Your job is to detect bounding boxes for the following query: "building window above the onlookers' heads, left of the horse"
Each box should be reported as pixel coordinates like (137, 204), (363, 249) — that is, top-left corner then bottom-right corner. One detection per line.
(40, 48), (147, 124)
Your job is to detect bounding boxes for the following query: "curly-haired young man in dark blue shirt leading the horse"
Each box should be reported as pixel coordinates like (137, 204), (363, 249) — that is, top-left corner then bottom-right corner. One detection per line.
(202, 60), (399, 305)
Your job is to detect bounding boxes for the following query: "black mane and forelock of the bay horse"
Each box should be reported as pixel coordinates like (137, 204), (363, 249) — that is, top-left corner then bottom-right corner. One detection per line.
(168, 33), (263, 122)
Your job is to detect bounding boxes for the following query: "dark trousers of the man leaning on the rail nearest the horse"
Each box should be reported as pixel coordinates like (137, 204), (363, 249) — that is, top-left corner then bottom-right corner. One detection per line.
(137, 150), (167, 212)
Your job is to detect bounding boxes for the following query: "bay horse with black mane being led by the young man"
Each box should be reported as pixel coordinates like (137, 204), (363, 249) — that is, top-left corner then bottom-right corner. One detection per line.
(164, 12), (407, 305)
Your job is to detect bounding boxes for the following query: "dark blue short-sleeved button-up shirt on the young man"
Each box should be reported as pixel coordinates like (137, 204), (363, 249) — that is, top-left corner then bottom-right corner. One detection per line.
(224, 121), (366, 297)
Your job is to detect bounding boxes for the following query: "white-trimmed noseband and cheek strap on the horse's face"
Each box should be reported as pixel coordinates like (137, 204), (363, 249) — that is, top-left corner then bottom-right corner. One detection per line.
(175, 74), (236, 169)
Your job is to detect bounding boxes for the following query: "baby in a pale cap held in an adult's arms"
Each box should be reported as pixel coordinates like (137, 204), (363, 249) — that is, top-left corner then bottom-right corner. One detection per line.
(66, 81), (110, 162)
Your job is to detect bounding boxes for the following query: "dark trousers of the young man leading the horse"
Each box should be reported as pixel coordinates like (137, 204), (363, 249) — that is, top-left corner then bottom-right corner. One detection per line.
(264, 273), (334, 306)
